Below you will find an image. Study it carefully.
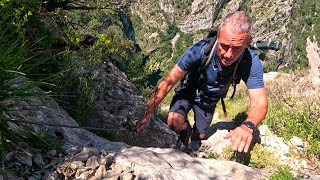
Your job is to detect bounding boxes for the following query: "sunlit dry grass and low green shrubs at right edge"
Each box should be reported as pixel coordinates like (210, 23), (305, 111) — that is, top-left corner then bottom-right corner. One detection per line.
(263, 77), (320, 157)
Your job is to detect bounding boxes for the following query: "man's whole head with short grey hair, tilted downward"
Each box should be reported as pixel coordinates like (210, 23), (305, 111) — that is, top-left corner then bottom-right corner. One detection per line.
(217, 11), (252, 66)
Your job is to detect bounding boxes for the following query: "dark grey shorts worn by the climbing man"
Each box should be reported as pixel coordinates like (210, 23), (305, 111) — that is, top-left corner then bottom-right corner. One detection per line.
(169, 94), (214, 134)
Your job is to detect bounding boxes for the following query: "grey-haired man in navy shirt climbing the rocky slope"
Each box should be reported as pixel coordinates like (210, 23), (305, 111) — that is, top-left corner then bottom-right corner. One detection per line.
(137, 12), (268, 152)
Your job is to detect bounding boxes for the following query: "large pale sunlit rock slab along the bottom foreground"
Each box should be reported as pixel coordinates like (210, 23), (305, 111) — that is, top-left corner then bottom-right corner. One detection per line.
(115, 147), (267, 180)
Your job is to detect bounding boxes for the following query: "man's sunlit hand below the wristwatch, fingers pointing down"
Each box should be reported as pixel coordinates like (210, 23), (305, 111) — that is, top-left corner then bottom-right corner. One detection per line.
(224, 125), (253, 153)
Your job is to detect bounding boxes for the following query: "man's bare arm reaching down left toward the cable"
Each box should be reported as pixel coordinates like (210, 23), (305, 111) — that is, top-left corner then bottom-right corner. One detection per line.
(136, 64), (186, 132)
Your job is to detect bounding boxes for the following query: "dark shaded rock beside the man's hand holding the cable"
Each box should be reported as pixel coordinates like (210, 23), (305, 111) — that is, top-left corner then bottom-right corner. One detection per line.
(87, 63), (178, 147)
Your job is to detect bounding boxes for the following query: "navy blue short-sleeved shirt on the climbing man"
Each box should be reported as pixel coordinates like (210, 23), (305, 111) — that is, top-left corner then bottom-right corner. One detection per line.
(175, 39), (264, 107)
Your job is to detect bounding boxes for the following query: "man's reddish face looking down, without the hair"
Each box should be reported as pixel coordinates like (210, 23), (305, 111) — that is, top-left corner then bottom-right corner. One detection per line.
(217, 25), (251, 66)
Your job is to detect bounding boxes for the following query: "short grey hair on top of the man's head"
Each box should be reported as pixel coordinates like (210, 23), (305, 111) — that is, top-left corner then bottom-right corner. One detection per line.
(219, 11), (252, 35)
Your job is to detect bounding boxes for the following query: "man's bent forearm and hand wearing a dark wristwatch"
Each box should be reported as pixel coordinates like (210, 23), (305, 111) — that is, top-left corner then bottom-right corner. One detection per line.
(224, 88), (268, 152)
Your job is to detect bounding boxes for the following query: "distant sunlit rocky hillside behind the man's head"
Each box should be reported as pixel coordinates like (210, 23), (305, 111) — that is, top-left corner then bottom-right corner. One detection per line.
(130, 0), (320, 76)
